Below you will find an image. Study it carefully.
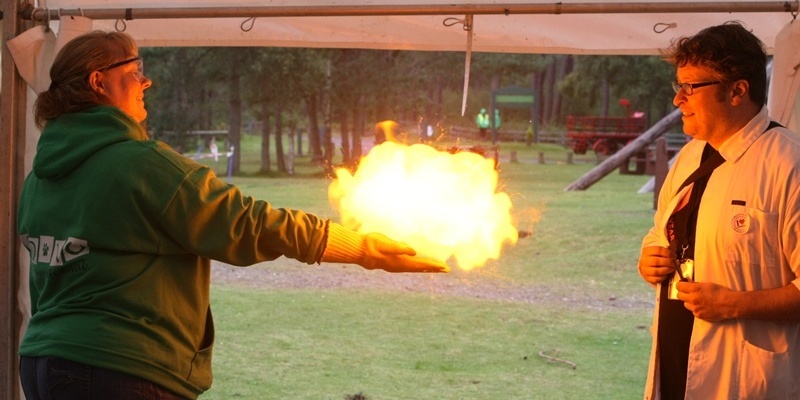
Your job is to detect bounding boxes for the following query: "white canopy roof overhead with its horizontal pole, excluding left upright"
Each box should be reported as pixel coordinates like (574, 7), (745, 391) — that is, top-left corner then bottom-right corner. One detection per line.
(17, 0), (797, 54)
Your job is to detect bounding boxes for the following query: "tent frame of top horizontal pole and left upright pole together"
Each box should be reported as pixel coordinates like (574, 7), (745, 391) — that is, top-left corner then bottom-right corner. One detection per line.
(0, 0), (800, 399)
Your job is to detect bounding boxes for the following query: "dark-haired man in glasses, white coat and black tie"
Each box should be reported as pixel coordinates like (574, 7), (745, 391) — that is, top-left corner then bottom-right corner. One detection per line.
(639, 22), (800, 399)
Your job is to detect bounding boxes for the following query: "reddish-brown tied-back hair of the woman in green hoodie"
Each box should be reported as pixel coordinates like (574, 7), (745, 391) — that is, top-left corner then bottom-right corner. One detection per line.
(33, 31), (138, 128)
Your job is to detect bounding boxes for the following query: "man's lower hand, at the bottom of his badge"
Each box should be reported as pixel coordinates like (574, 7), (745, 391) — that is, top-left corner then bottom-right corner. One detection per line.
(678, 282), (738, 322)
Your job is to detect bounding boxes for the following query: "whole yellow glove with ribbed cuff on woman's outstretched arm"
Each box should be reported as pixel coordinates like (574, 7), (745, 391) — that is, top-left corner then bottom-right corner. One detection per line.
(322, 222), (450, 272)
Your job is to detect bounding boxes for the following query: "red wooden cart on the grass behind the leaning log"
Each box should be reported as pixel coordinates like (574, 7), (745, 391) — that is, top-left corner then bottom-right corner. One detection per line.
(566, 113), (647, 155)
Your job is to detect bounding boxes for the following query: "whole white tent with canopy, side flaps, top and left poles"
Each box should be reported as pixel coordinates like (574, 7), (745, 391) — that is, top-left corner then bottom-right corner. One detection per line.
(0, 0), (800, 399)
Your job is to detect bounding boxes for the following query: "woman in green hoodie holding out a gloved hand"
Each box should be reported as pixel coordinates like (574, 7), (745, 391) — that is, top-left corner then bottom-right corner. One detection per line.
(17, 31), (448, 400)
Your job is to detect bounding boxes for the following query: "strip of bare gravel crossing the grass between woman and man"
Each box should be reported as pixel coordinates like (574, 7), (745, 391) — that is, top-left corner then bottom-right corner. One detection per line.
(212, 258), (653, 310)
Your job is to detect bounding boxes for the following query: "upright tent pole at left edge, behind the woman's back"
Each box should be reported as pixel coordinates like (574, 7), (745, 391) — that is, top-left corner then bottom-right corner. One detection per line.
(0, 0), (27, 399)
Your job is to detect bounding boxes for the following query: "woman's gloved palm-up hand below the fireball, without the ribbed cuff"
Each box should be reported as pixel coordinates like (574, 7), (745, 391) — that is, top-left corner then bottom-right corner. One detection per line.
(359, 233), (450, 272)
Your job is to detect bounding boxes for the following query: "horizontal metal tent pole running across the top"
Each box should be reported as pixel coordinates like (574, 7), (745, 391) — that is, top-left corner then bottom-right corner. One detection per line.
(22, 1), (800, 21)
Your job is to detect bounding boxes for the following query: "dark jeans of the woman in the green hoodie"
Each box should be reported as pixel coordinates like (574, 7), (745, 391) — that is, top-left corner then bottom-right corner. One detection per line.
(19, 356), (185, 400)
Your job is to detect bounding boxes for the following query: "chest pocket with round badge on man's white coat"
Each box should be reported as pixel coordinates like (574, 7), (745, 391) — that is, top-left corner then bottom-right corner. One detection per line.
(721, 206), (785, 290)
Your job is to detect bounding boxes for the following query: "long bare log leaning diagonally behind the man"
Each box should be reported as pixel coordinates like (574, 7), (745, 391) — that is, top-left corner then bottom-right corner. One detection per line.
(564, 108), (682, 191)
